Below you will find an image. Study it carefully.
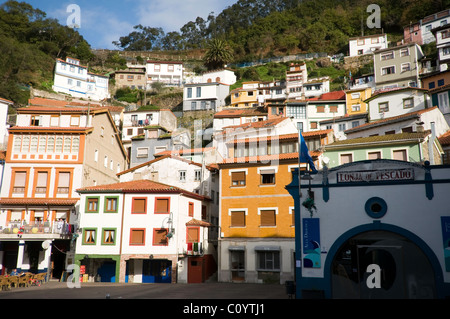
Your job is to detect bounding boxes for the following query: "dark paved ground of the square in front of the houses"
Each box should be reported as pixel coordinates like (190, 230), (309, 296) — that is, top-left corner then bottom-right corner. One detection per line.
(0, 281), (288, 300)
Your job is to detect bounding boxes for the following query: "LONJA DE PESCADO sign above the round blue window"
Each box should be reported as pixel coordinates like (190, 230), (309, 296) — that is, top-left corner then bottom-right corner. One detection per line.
(337, 168), (414, 183)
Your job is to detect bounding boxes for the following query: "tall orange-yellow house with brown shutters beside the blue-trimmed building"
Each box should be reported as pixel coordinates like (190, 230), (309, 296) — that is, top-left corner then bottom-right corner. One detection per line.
(218, 134), (317, 284)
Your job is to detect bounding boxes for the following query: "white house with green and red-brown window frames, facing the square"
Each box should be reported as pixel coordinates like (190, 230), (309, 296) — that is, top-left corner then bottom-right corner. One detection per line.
(75, 180), (216, 283)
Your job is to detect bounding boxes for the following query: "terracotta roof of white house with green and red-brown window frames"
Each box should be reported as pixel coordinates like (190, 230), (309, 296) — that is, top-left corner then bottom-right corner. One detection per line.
(77, 179), (207, 200)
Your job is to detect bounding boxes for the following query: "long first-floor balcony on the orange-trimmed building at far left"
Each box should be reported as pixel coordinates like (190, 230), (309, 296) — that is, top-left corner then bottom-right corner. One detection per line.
(0, 221), (73, 238)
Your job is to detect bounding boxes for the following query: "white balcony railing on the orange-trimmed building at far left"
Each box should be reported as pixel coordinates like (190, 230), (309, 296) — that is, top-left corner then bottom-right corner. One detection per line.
(0, 221), (73, 236)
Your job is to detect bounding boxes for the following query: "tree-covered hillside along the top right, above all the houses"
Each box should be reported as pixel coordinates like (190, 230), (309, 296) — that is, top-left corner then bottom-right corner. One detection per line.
(114, 0), (450, 62)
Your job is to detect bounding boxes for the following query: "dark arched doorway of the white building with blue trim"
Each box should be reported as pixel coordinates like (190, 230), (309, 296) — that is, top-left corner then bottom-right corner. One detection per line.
(330, 230), (437, 299)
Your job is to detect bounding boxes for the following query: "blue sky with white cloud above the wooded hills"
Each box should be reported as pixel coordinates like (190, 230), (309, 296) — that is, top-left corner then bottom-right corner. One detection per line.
(0, 0), (238, 49)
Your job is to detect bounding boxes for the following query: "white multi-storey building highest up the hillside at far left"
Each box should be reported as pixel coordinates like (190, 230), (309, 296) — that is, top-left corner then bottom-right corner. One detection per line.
(53, 57), (110, 101)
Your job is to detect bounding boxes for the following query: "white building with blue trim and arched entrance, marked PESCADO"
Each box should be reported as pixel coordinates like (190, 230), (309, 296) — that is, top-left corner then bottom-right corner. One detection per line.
(286, 160), (450, 299)
